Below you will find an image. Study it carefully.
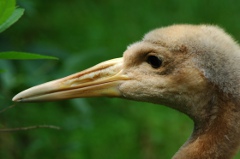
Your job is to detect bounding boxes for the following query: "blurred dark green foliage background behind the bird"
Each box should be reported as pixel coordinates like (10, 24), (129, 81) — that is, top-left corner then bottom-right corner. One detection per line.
(0, 0), (240, 159)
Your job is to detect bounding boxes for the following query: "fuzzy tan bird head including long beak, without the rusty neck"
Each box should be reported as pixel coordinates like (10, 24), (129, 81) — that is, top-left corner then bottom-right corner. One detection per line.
(13, 25), (239, 117)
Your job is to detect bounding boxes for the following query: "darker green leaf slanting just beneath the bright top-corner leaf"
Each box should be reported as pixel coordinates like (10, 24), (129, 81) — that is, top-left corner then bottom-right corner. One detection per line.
(0, 8), (24, 33)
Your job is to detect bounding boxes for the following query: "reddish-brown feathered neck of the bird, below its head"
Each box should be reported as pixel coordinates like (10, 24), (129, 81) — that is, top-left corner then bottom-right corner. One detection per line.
(173, 94), (240, 159)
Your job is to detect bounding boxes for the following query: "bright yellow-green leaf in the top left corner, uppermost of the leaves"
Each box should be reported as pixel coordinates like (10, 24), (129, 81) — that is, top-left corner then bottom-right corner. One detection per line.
(0, 0), (16, 25)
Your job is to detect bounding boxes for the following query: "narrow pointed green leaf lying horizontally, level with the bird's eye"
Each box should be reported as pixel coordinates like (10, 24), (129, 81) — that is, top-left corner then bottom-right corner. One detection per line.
(0, 51), (58, 60)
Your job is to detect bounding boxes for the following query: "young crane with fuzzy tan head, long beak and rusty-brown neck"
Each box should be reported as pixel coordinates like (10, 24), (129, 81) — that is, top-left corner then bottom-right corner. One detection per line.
(13, 25), (240, 159)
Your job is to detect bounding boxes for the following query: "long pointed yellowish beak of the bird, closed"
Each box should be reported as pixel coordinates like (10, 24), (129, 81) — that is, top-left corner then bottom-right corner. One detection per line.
(12, 58), (129, 102)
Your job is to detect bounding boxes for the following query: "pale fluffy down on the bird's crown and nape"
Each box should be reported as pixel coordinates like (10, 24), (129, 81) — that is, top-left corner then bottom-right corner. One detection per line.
(143, 25), (240, 98)
